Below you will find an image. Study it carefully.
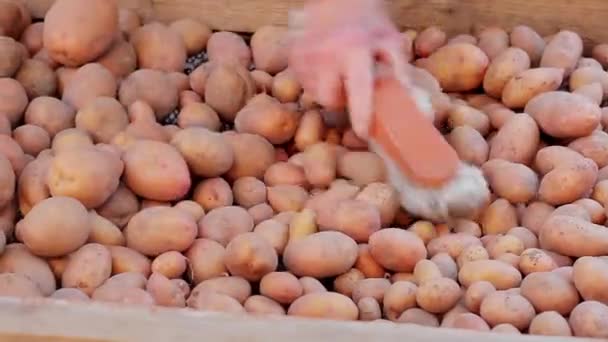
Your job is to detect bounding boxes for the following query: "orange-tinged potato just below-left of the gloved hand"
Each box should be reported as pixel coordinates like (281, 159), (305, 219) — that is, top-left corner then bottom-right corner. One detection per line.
(234, 94), (298, 145)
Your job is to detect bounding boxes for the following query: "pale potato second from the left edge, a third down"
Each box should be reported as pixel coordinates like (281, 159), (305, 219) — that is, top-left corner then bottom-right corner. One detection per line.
(25, 96), (76, 138)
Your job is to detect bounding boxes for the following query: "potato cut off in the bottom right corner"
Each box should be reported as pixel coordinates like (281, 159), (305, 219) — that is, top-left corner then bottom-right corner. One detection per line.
(569, 300), (608, 338)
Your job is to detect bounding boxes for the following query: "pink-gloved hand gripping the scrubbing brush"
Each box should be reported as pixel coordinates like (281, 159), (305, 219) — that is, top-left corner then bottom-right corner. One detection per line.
(289, 0), (407, 139)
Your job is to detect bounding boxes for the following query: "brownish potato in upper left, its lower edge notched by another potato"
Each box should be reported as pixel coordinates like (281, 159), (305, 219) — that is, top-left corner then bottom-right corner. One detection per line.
(118, 69), (179, 119)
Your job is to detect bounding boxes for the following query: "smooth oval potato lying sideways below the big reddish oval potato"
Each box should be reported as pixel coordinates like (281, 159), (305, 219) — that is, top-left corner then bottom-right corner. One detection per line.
(125, 206), (197, 256)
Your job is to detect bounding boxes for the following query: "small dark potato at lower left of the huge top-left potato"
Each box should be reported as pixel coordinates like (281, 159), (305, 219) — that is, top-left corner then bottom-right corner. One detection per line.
(15, 59), (57, 99)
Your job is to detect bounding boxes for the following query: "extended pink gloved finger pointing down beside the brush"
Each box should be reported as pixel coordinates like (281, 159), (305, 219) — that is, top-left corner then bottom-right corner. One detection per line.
(344, 50), (374, 139)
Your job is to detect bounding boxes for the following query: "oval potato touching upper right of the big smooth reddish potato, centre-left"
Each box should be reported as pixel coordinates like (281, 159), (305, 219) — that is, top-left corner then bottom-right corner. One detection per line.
(171, 127), (234, 178)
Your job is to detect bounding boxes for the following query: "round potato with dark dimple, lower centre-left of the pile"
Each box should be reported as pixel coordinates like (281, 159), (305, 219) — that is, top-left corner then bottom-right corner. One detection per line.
(224, 232), (278, 281)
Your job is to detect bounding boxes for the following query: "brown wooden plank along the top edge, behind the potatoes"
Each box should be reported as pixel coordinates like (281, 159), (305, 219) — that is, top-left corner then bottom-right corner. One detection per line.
(152, 0), (608, 49)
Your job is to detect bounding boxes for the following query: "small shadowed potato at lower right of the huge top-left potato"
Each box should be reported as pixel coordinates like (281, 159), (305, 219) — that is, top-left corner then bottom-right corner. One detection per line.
(97, 39), (137, 80)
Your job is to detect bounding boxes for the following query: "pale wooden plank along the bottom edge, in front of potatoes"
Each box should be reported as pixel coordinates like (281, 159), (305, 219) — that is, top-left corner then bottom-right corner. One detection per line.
(0, 298), (597, 342)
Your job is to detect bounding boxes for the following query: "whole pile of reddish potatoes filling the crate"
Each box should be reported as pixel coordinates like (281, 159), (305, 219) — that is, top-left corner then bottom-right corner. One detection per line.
(0, 0), (608, 338)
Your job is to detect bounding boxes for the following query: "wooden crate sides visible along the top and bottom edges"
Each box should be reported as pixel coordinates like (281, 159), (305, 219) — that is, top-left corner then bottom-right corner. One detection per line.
(13, 0), (608, 342)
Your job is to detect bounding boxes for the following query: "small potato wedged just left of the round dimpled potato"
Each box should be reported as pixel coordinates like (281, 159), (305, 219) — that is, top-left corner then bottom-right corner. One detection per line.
(184, 239), (228, 284)
